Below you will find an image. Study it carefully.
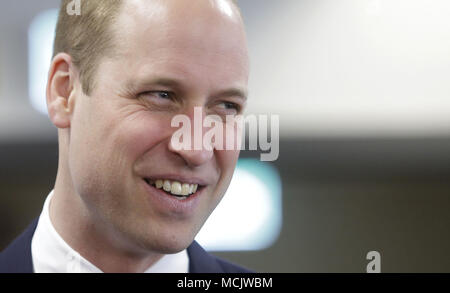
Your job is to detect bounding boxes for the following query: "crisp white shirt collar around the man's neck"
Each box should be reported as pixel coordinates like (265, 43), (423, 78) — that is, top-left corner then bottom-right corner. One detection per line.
(31, 191), (189, 273)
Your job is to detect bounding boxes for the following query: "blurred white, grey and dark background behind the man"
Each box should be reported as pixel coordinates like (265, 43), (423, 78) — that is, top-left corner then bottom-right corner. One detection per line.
(0, 0), (450, 272)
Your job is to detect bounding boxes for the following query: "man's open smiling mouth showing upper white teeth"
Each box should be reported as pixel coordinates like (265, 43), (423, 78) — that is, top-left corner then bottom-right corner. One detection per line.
(144, 178), (205, 200)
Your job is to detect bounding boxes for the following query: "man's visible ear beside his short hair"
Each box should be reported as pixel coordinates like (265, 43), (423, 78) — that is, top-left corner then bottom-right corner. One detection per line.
(47, 53), (77, 128)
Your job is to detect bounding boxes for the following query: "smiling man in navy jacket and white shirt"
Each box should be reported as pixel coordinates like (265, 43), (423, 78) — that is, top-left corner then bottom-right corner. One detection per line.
(0, 0), (248, 272)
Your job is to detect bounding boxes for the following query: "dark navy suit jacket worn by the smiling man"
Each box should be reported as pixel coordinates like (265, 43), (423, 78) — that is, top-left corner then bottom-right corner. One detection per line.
(0, 219), (250, 273)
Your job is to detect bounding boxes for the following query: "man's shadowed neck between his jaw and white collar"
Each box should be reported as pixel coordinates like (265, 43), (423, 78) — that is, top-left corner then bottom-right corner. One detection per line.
(50, 166), (163, 273)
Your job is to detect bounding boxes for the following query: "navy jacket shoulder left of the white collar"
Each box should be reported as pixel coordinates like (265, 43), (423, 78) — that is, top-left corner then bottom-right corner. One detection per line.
(0, 218), (39, 273)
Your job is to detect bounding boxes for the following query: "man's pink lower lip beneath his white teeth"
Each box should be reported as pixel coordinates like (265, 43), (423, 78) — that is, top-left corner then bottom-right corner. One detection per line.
(142, 180), (204, 216)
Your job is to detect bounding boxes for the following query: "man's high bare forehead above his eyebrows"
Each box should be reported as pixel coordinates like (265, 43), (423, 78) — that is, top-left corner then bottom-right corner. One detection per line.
(109, 0), (248, 85)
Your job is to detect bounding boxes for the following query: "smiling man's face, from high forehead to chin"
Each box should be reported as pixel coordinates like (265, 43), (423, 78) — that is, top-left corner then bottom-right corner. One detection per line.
(68, 0), (248, 253)
